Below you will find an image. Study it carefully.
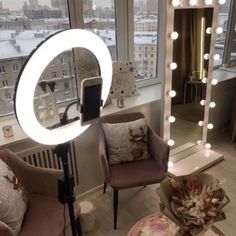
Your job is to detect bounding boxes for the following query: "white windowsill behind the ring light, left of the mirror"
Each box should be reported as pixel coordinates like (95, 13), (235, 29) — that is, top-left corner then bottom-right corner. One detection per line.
(0, 84), (161, 148)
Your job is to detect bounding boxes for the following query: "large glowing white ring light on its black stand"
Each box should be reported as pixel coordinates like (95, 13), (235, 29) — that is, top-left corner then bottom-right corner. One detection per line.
(14, 29), (112, 236)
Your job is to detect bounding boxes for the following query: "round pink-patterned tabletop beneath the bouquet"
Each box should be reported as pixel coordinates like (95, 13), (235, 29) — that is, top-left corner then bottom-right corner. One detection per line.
(128, 213), (225, 236)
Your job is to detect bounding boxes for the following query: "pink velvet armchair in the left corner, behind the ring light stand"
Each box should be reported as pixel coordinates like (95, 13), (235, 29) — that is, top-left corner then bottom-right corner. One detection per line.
(0, 149), (80, 236)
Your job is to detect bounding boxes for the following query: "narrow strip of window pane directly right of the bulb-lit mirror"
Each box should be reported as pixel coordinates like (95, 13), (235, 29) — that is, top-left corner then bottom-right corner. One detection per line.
(214, 0), (230, 66)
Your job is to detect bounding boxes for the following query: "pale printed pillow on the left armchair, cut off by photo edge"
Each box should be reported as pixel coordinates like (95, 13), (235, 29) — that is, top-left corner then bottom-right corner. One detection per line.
(0, 159), (27, 234)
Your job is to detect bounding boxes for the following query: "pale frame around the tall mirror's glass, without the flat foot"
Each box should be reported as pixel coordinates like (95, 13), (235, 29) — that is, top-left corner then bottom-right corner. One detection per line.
(158, 0), (220, 171)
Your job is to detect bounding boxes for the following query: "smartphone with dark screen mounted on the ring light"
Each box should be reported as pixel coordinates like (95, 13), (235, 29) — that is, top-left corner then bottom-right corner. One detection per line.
(80, 76), (102, 126)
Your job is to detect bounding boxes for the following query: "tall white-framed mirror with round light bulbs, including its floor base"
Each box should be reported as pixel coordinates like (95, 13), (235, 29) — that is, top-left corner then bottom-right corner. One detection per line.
(158, 0), (223, 176)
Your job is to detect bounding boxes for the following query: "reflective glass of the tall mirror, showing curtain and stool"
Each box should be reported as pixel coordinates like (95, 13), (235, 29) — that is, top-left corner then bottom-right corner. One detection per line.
(170, 8), (213, 155)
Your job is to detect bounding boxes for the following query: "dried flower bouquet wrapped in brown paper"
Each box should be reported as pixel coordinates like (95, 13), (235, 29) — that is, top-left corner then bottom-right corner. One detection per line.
(158, 174), (229, 235)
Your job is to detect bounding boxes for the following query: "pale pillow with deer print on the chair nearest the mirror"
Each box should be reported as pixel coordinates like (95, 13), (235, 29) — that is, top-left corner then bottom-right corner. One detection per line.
(102, 118), (149, 164)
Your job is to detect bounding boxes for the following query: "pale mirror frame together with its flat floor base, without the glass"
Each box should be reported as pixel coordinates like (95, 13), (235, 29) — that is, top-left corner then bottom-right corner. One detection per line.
(158, 0), (223, 176)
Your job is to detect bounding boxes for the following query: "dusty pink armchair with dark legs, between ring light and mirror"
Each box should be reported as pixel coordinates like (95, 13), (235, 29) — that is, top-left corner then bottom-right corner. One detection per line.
(99, 113), (169, 229)
